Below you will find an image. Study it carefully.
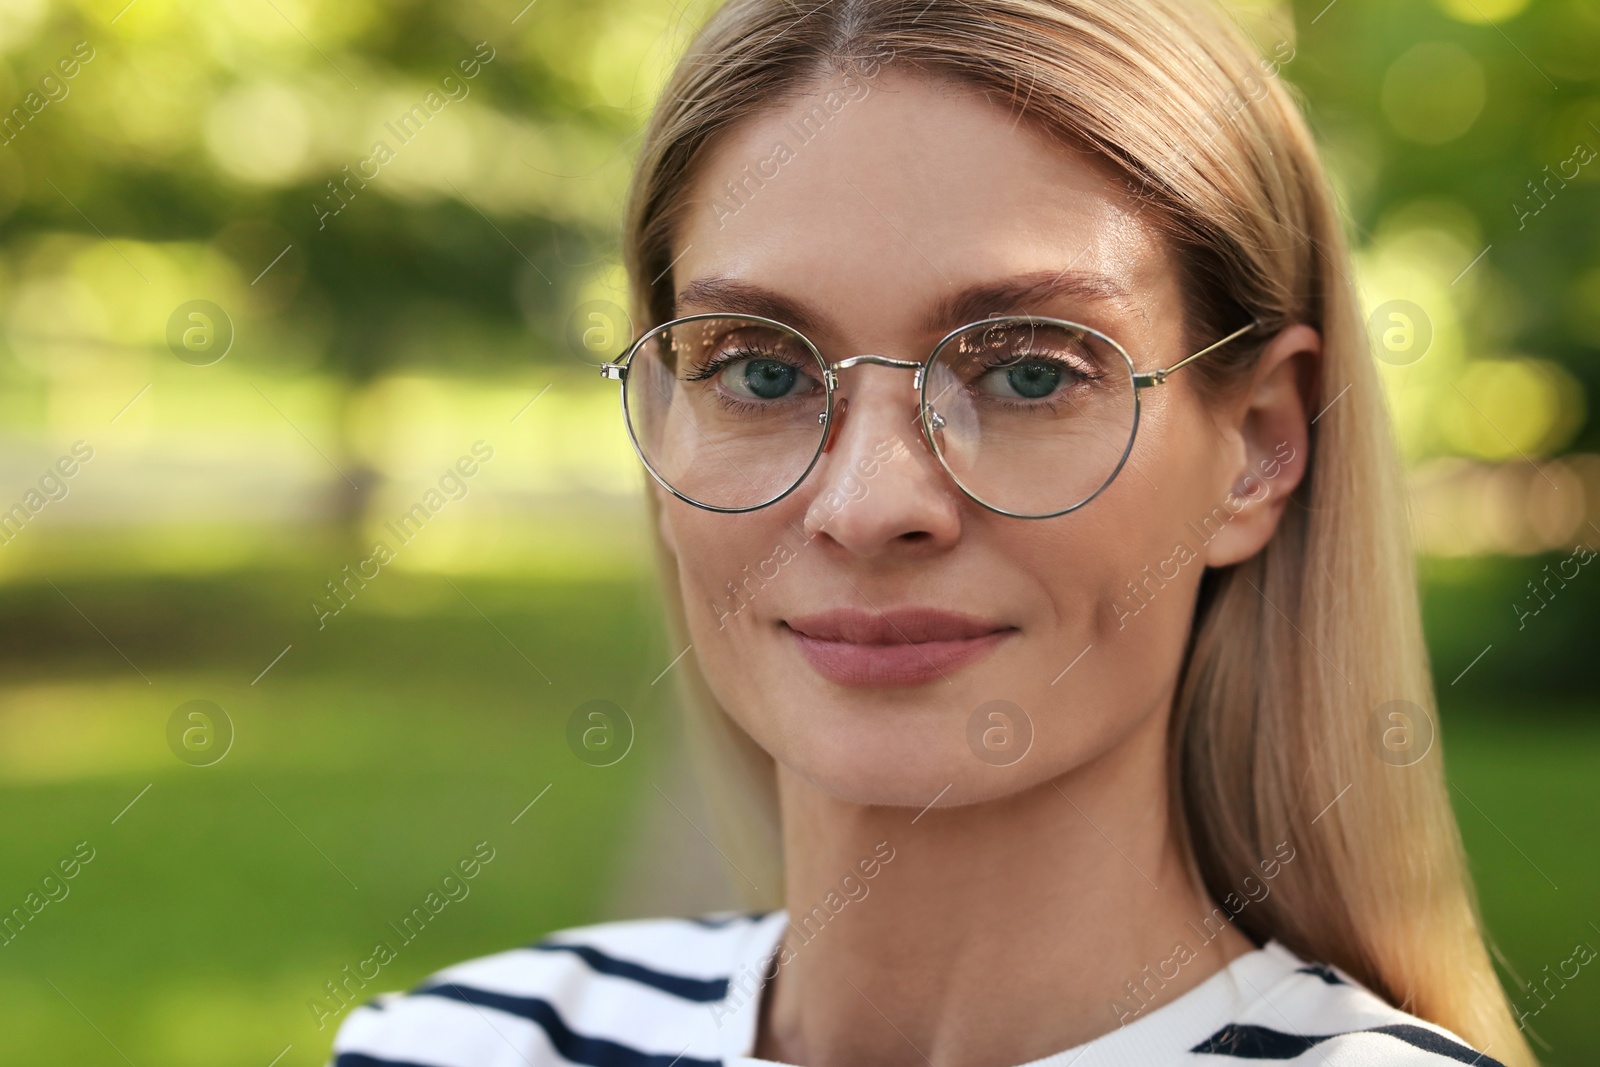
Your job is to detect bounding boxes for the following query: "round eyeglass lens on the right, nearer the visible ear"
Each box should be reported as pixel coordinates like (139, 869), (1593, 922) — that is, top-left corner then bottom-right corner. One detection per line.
(923, 317), (1139, 518)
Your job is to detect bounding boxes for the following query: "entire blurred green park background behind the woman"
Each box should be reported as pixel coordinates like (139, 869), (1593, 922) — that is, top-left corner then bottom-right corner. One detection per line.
(0, 0), (1600, 1067)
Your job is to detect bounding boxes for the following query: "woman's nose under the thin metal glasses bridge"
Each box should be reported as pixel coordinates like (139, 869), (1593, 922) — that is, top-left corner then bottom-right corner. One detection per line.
(805, 366), (962, 558)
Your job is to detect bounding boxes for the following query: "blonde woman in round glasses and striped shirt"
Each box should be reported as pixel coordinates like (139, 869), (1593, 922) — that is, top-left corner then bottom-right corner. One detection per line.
(334, 0), (1534, 1067)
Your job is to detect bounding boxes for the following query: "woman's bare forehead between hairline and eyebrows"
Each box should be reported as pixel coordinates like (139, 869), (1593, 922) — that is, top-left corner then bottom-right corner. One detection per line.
(672, 70), (1176, 343)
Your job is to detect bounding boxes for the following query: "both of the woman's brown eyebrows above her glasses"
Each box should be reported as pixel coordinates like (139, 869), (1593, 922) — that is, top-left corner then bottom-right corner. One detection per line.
(672, 270), (1131, 333)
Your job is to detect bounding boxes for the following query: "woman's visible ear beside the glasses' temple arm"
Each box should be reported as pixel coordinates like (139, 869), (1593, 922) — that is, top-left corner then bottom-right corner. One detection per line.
(1205, 323), (1322, 566)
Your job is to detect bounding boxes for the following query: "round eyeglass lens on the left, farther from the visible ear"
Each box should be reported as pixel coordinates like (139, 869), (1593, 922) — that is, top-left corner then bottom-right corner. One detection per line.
(622, 315), (827, 510)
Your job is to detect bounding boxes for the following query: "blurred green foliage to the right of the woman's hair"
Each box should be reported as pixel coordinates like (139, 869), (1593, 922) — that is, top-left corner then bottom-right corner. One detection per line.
(1286, 0), (1600, 459)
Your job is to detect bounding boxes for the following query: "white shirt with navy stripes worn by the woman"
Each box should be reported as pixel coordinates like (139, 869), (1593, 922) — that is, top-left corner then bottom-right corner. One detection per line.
(330, 912), (1502, 1067)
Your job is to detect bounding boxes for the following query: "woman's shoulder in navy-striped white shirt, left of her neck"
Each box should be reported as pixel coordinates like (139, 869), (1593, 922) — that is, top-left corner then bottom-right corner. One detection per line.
(330, 913), (781, 1067)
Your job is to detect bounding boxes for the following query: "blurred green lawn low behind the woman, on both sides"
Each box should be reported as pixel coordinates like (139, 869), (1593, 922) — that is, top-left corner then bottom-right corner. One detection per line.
(0, 571), (1600, 1067)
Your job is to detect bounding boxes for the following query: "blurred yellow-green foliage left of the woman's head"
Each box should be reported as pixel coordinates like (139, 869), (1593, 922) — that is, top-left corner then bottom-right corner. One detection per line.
(0, 0), (688, 391)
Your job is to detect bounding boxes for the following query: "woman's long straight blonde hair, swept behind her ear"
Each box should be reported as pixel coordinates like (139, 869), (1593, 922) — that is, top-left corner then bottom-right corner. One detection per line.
(622, 0), (1536, 1067)
